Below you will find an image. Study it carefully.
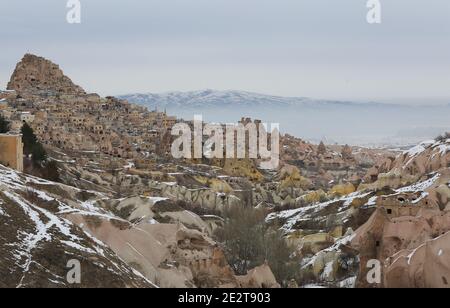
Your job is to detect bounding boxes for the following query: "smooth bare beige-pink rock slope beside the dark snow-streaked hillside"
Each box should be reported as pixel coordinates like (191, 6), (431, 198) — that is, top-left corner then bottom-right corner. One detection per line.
(68, 213), (237, 288)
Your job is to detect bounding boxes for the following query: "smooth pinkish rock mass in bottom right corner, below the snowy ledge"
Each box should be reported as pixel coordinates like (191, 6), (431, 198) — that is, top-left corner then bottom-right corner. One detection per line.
(352, 196), (450, 287)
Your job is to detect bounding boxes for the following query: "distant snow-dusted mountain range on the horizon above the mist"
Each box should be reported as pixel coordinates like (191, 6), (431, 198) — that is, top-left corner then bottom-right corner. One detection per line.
(119, 90), (392, 109)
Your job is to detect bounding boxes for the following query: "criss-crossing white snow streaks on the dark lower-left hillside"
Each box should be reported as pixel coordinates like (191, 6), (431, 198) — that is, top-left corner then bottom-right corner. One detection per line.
(0, 165), (155, 288)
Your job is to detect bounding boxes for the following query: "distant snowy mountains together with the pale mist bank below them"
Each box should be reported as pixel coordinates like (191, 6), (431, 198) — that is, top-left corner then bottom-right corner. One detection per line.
(119, 90), (450, 147)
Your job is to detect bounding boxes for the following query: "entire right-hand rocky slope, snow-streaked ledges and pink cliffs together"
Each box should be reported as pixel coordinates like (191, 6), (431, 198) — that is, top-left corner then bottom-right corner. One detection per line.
(267, 138), (450, 288)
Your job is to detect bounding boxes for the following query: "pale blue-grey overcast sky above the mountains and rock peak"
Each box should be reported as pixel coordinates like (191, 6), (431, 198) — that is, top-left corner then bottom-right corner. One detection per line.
(0, 0), (450, 102)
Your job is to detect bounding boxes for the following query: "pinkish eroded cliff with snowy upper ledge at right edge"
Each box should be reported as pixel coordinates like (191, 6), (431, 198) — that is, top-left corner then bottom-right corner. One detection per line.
(352, 134), (450, 288)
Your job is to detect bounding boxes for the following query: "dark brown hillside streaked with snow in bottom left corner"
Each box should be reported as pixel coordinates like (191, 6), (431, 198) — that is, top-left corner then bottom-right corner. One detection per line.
(0, 166), (155, 287)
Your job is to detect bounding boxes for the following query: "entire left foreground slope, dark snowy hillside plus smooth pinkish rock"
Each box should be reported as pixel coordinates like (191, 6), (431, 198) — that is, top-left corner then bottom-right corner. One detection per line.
(0, 166), (278, 288)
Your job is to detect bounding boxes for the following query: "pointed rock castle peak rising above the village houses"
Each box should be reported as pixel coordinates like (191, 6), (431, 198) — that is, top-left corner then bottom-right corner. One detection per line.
(7, 54), (85, 94)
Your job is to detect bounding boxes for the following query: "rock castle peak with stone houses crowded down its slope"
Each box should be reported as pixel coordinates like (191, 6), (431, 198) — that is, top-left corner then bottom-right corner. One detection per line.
(0, 54), (177, 159)
